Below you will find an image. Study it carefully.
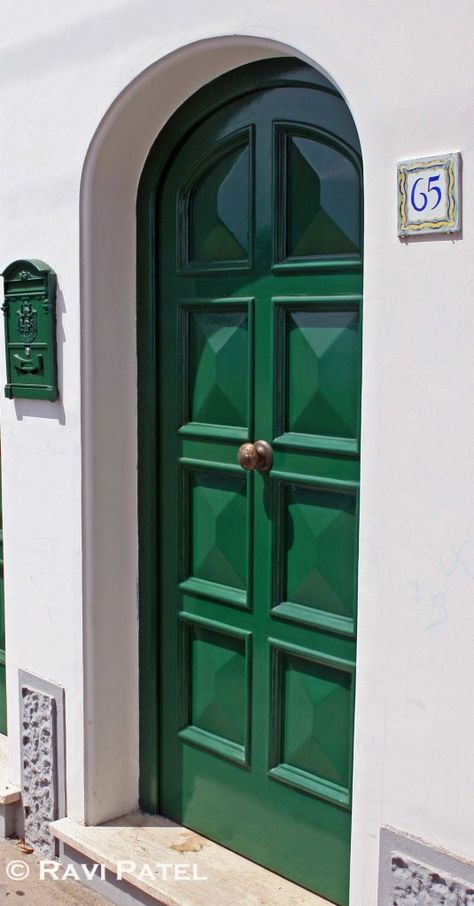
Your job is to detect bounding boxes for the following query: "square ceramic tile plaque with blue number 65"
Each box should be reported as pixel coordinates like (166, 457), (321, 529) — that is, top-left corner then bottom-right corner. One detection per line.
(398, 153), (461, 236)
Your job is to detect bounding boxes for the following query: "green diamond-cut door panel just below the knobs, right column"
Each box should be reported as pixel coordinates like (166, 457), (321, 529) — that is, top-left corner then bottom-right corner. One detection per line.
(274, 482), (357, 634)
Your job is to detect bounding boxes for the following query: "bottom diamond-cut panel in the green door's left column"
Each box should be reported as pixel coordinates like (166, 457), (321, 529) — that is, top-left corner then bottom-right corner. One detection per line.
(180, 617), (250, 762)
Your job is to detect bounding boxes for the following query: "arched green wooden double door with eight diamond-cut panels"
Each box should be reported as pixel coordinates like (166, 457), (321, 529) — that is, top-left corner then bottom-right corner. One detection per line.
(141, 58), (362, 904)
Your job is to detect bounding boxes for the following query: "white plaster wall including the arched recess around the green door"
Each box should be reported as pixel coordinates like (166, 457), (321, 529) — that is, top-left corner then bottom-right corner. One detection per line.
(0, 0), (474, 906)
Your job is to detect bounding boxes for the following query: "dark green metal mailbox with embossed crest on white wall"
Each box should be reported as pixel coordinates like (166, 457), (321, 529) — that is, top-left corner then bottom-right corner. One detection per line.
(2, 259), (58, 401)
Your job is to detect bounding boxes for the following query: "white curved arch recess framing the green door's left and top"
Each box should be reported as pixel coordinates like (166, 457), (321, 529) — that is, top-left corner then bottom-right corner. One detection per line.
(81, 37), (362, 824)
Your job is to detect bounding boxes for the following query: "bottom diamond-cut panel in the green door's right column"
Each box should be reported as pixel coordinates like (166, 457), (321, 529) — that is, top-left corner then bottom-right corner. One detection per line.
(270, 646), (353, 805)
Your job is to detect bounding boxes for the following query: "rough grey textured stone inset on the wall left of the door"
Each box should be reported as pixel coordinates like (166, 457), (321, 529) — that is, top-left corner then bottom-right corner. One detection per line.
(21, 686), (57, 858)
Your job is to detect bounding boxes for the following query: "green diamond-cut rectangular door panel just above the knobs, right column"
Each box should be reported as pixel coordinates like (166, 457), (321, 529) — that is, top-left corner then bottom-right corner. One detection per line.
(276, 302), (360, 452)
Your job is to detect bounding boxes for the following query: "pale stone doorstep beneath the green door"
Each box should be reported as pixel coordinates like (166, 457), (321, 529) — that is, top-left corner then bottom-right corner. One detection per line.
(50, 812), (331, 906)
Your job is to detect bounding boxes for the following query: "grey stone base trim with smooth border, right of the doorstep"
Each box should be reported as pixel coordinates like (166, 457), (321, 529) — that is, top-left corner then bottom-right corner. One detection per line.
(378, 828), (474, 906)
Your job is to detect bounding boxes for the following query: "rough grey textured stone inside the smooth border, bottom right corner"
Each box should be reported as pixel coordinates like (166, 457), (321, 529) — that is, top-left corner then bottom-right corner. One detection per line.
(390, 853), (474, 906)
